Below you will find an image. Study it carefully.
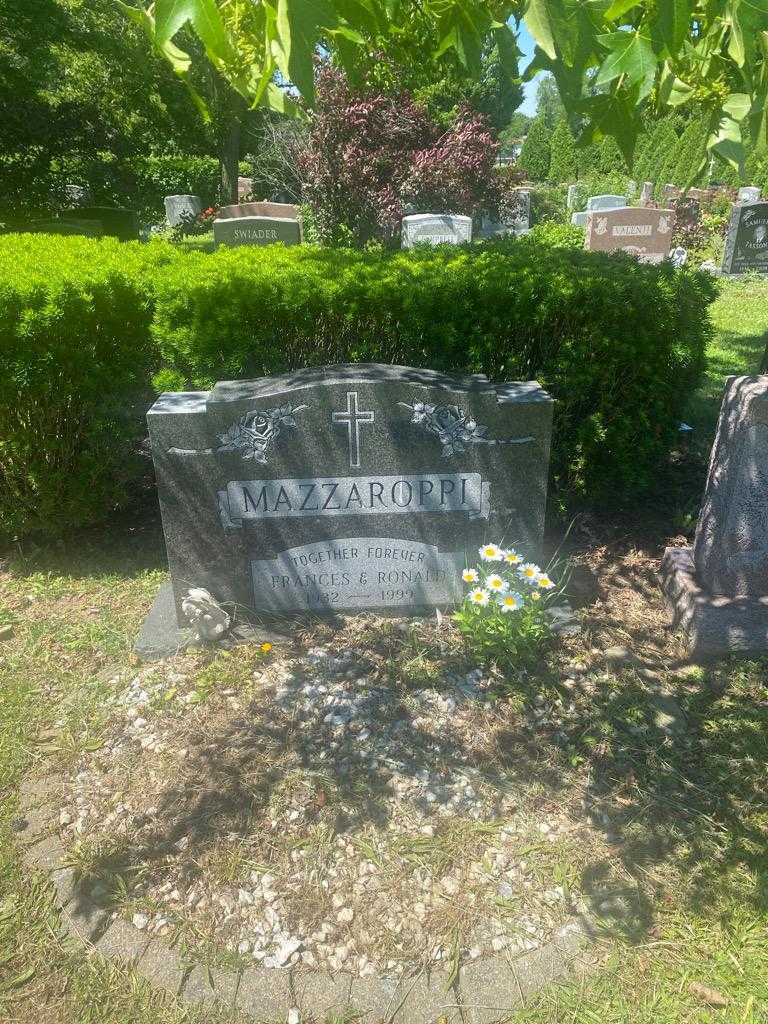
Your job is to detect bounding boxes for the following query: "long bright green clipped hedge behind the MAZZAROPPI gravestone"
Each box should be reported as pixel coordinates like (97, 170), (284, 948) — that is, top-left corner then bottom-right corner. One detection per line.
(0, 229), (714, 535)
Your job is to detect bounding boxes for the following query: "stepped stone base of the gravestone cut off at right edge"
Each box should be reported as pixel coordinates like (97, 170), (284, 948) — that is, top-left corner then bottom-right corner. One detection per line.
(662, 548), (768, 660)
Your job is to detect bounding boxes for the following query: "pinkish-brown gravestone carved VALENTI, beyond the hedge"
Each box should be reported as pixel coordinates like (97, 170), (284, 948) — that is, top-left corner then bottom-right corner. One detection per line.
(585, 207), (675, 263)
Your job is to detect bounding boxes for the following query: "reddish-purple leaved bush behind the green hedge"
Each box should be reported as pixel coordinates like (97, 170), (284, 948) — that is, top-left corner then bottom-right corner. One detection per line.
(300, 65), (499, 245)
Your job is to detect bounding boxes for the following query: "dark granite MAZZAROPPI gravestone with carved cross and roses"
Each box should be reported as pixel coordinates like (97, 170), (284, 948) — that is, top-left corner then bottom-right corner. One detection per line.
(141, 364), (553, 646)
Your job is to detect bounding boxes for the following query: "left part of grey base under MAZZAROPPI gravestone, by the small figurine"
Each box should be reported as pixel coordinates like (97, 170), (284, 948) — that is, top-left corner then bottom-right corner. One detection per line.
(133, 580), (290, 662)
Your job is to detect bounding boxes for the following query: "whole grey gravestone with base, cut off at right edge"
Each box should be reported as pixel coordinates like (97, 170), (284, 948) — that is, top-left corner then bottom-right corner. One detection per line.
(662, 376), (768, 657)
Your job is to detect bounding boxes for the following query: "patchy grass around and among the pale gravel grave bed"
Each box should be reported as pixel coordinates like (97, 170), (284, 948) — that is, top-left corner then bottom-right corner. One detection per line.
(0, 524), (768, 1024)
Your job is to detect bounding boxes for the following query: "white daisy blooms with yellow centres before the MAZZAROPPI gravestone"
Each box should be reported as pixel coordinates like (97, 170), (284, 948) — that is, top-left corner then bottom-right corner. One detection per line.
(462, 544), (555, 612)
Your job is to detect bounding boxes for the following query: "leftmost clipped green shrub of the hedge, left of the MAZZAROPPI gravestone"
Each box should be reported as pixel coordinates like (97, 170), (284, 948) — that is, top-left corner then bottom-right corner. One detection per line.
(0, 234), (179, 538)
